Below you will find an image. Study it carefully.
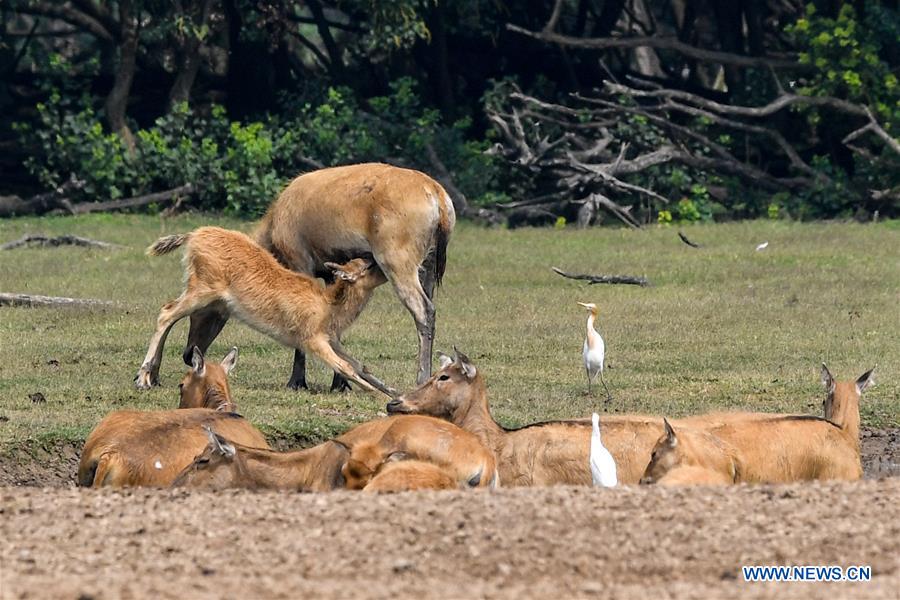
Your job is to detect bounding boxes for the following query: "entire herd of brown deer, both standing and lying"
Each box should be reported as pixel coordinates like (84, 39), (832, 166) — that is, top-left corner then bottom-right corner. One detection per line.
(78, 164), (873, 491)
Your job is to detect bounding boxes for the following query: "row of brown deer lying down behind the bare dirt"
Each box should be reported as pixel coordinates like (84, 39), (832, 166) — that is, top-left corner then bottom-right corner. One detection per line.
(78, 350), (872, 492)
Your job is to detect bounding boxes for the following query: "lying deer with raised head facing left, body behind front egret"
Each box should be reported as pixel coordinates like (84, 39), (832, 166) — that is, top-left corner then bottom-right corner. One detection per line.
(387, 351), (663, 486)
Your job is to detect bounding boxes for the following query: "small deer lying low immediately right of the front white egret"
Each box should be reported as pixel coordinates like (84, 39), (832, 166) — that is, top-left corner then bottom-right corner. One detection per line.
(641, 419), (742, 485)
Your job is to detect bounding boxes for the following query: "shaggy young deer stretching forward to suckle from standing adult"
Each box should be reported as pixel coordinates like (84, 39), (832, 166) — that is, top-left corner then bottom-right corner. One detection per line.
(135, 227), (395, 397)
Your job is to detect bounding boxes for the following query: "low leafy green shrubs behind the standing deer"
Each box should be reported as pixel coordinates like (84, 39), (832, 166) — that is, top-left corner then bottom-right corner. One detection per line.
(17, 78), (499, 216)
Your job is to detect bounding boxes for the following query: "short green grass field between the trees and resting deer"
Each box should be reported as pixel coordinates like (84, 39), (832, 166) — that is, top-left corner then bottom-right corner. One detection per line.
(0, 215), (900, 452)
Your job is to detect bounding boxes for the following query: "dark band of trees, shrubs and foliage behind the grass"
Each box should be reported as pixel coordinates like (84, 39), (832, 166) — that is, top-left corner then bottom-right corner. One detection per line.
(0, 0), (900, 223)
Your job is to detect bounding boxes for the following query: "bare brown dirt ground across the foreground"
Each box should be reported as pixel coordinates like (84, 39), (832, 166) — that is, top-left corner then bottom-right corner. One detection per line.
(0, 478), (900, 599)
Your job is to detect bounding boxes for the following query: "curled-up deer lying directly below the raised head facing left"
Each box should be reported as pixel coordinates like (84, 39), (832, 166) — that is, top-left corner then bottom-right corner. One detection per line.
(339, 415), (497, 490)
